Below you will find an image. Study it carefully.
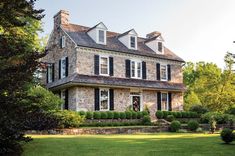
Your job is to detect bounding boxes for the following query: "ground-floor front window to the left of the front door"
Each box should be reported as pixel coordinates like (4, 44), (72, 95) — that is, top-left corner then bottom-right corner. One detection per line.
(100, 89), (109, 110)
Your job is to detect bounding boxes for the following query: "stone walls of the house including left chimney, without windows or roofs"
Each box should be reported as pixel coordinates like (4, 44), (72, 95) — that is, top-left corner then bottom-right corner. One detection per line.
(42, 11), (183, 118)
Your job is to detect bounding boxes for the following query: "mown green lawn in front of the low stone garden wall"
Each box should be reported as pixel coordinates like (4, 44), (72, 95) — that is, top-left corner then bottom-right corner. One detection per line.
(23, 133), (235, 156)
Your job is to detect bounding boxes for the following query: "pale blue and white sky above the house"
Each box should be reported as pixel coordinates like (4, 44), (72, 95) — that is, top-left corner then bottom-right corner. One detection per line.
(36, 0), (235, 68)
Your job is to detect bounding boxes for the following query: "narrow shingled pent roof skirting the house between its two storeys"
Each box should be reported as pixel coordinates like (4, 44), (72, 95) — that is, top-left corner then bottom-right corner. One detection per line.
(47, 74), (186, 91)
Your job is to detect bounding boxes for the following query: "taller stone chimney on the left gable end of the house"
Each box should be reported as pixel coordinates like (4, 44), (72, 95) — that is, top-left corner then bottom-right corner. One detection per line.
(54, 10), (69, 29)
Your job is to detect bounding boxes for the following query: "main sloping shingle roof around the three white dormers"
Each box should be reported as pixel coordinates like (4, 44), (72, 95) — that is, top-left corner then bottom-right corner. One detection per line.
(61, 24), (184, 62)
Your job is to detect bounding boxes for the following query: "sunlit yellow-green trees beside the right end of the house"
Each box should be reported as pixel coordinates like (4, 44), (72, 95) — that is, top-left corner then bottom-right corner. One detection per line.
(183, 53), (235, 112)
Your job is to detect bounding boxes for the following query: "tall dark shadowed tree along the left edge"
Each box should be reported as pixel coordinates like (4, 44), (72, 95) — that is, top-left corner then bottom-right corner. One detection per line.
(0, 0), (45, 155)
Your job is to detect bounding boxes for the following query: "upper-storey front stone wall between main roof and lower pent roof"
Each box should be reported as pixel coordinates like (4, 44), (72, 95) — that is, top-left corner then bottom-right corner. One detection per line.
(77, 48), (183, 83)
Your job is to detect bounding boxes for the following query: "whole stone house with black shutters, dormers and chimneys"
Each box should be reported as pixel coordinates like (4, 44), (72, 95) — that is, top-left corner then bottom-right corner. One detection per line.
(43, 10), (185, 116)
